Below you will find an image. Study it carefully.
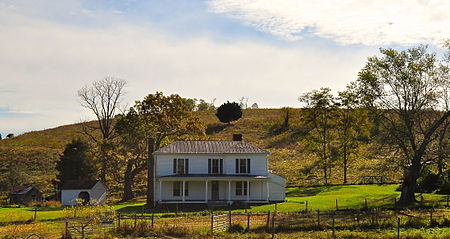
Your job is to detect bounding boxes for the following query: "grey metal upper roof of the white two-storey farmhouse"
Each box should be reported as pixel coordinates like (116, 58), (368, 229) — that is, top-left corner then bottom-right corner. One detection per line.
(154, 140), (268, 154)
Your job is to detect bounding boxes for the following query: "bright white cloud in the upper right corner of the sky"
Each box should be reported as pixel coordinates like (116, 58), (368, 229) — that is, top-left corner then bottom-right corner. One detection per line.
(209, 0), (450, 45)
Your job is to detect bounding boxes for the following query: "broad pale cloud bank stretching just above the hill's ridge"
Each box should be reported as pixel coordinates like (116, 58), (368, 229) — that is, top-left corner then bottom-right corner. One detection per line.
(0, 4), (373, 134)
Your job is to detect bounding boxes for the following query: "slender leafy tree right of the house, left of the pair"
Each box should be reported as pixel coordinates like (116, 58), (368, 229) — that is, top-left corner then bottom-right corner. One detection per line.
(299, 88), (336, 184)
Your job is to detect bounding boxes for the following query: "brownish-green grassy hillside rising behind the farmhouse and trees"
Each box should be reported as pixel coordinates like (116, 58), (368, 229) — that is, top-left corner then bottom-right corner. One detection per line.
(0, 109), (398, 197)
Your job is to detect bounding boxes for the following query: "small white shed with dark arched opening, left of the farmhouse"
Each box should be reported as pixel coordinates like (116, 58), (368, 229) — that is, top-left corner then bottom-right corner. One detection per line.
(61, 180), (107, 206)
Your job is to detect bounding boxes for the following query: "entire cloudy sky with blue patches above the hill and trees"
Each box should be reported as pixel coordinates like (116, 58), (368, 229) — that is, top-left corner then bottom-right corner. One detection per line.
(0, 0), (450, 137)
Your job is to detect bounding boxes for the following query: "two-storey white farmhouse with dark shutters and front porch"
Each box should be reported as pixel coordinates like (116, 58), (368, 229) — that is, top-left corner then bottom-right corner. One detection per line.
(153, 135), (285, 204)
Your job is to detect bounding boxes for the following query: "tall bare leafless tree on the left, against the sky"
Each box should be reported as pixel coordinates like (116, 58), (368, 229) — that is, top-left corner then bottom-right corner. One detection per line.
(78, 77), (126, 182)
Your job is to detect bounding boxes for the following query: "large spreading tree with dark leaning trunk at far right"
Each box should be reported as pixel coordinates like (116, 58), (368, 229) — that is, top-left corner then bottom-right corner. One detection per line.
(357, 46), (450, 205)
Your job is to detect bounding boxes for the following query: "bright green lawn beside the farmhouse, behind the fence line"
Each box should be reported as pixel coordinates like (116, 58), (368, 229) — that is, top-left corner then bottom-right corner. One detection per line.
(0, 184), (445, 223)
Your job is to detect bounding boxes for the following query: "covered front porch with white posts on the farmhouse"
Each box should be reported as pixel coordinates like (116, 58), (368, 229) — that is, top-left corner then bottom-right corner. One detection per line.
(155, 175), (270, 205)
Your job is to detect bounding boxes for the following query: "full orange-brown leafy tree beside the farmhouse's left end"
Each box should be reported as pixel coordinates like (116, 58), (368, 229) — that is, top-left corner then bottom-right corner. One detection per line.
(117, 92), (205, 201)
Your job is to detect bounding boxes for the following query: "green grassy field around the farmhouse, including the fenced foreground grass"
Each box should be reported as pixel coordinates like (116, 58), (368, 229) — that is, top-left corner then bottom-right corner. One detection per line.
(0, 184), (450, 239)
